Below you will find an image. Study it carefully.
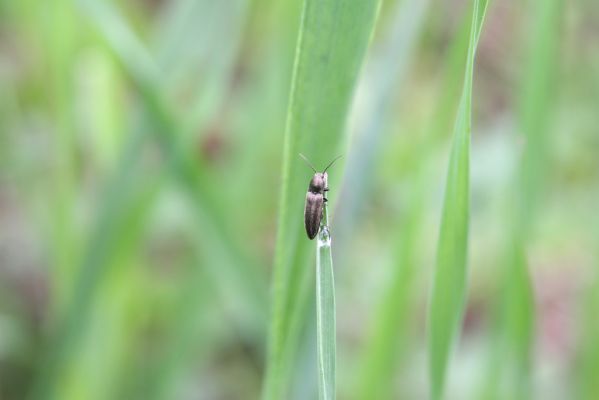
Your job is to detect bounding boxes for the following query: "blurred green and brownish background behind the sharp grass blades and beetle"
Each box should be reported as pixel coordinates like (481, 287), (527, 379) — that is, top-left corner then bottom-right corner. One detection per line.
(0, 0), (599, 399)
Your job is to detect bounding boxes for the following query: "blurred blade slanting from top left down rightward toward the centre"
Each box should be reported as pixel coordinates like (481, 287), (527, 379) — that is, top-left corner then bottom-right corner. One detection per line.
(80, 0), (266, 318)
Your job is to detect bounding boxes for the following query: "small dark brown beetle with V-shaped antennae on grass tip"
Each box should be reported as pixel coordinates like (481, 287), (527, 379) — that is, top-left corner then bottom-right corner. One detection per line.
(300, 153), (341, 240)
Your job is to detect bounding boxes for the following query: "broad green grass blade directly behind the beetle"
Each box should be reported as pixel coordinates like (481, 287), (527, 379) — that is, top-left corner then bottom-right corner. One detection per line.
(263, 0), (379, 400)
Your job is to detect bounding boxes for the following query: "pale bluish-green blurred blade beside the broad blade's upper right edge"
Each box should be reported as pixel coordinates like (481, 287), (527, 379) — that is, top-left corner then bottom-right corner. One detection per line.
(335, 0), (429, 261)
